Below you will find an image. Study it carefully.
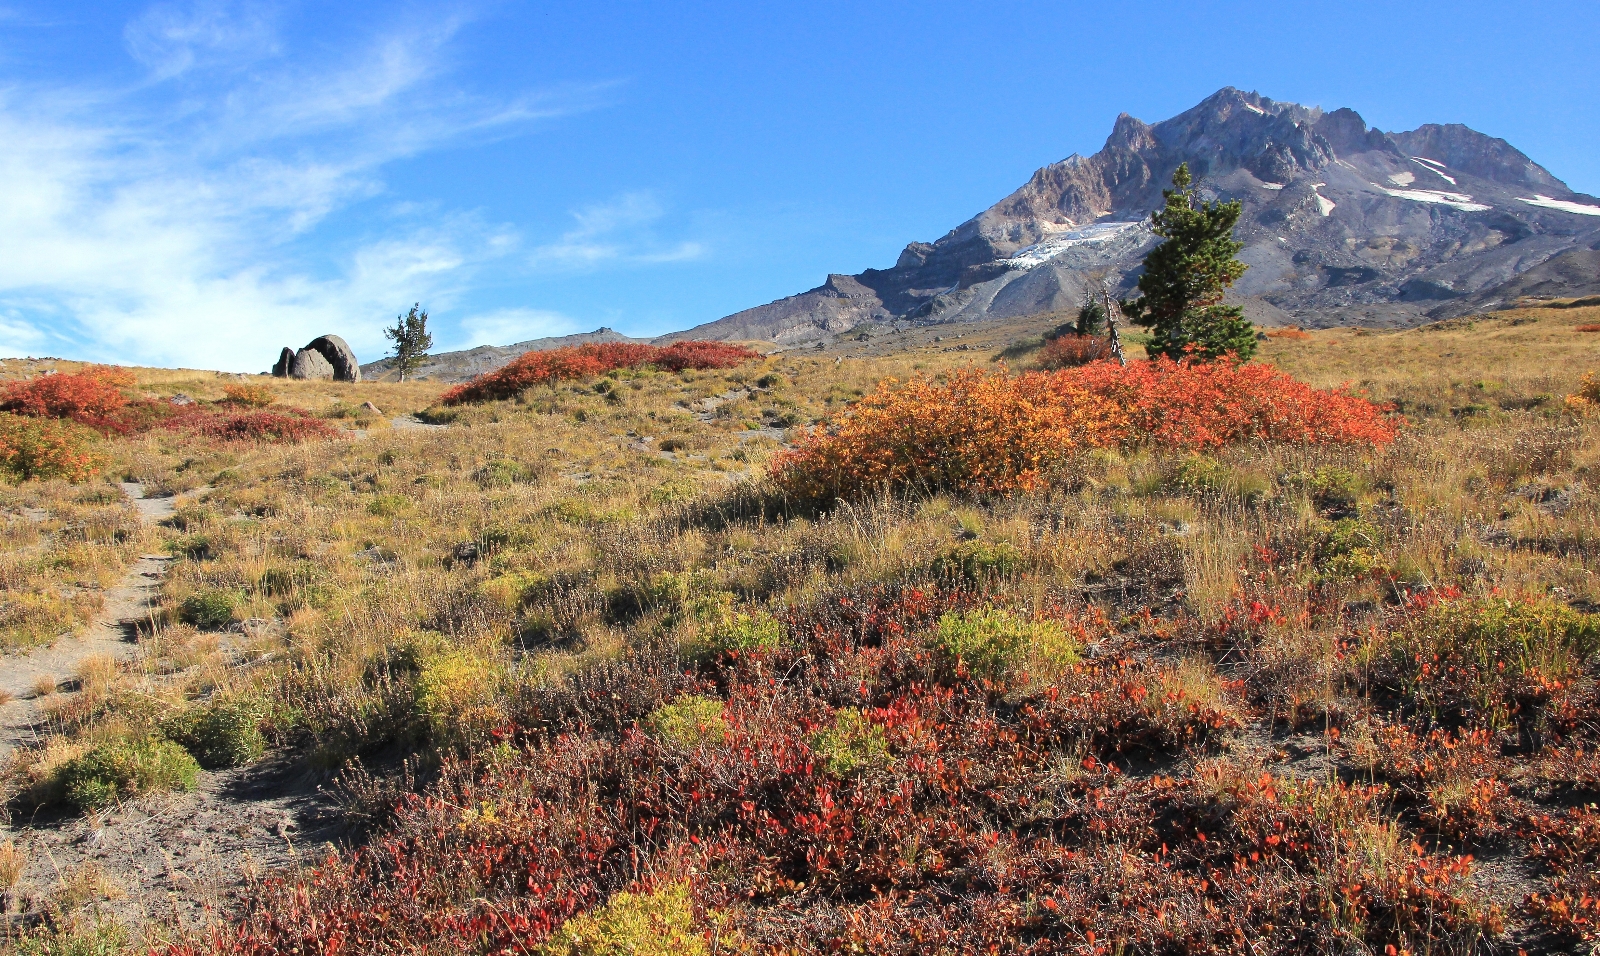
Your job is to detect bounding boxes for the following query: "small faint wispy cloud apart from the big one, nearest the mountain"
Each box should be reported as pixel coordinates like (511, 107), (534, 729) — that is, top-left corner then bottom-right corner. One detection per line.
(530, 192), (707, 270)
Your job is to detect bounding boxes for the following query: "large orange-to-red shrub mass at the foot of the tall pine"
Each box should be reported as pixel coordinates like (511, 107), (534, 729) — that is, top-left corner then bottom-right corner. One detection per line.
(771, 358), (1395, 500)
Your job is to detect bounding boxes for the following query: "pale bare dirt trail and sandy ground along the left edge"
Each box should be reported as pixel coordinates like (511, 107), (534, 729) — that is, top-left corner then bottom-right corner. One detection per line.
(0, 483), (342, 932)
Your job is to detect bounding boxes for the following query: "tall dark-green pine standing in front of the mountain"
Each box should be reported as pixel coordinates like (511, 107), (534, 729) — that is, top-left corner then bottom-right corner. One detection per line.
(1122, 163), (1256, 360)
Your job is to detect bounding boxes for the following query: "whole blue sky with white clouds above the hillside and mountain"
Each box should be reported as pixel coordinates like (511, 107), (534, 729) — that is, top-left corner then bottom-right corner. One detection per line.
(0, 0), (1600, 371)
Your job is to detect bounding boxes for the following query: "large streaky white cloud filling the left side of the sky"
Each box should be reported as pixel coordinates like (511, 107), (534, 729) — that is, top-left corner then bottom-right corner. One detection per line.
(0, 3), (611, 371)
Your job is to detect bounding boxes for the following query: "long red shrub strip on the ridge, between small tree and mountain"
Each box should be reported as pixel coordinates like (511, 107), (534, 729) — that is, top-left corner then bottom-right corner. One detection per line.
(440, 342), (760, 404)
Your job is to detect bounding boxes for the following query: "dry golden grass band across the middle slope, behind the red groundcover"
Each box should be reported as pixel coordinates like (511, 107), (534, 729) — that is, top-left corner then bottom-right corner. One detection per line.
(0, 309), (1600, 952)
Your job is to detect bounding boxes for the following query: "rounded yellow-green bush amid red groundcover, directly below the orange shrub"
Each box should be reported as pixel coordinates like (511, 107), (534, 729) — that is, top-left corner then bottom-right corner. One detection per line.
(933, 607), (1078, 681)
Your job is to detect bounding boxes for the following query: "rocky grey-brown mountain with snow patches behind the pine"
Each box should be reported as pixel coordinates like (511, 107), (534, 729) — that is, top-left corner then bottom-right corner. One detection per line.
(669, 88), (1600, 344)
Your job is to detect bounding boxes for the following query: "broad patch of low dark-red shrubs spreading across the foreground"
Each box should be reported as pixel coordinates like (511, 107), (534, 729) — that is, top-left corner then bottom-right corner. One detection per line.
(170, 587), (1494, 956)
